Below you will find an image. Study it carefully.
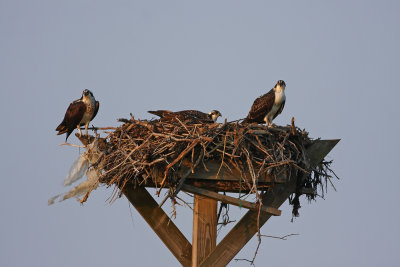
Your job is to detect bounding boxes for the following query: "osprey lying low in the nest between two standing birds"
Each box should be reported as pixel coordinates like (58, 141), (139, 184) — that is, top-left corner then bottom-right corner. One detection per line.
(147, 110), (222, 123)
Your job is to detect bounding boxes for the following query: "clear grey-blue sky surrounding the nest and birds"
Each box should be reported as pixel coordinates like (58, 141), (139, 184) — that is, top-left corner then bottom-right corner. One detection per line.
(0, 0), (400, 267)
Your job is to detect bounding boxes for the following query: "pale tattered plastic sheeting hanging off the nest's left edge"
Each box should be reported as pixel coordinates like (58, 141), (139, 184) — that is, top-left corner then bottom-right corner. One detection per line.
(48, 140), (104, 205)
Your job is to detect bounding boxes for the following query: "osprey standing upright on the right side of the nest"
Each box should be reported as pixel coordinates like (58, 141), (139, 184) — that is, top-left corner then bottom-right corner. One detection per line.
(243, 80), (286, 126)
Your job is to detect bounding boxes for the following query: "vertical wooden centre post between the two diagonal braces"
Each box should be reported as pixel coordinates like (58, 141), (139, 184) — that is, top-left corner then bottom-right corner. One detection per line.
(192, 195), (217, 267)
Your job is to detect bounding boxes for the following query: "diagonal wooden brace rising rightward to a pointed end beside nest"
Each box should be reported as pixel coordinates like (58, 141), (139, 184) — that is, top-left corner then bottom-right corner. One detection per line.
(200, 140), (340, 267)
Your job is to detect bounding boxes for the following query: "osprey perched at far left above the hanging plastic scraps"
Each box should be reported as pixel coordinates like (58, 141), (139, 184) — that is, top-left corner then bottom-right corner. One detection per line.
(56, 89), (100, 142)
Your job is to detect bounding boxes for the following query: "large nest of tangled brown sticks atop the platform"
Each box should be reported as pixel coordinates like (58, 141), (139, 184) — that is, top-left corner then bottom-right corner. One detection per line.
(90, 118), (334, 216)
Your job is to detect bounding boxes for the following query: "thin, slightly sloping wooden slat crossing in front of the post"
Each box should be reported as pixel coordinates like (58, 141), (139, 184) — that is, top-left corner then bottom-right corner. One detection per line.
(182, 184), (282, 216)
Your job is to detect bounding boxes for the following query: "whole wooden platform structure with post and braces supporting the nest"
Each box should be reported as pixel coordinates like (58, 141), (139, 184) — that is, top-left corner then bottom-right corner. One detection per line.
(123, 139), (340, 267)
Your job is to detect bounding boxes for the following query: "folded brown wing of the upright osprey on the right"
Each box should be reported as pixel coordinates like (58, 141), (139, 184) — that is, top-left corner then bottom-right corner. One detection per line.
(243, 89), (275, 123)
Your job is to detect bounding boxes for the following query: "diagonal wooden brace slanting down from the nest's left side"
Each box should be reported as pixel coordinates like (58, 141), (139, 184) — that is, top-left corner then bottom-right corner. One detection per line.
(122, 185), (192, 267)
